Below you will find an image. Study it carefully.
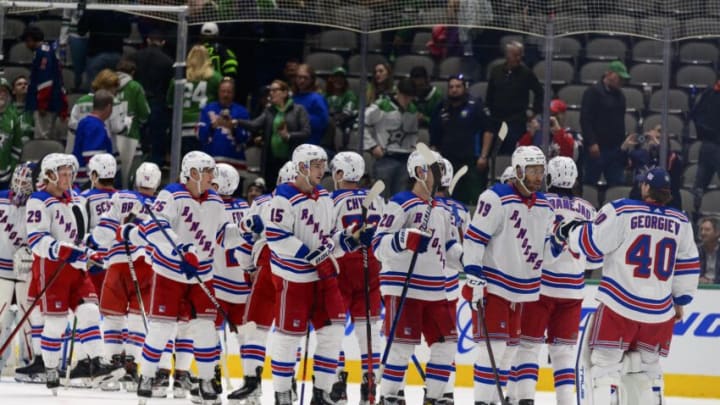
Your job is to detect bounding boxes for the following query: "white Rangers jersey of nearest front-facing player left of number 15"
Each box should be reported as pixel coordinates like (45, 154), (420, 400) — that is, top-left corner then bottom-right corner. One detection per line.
(141, 183), (243, 284)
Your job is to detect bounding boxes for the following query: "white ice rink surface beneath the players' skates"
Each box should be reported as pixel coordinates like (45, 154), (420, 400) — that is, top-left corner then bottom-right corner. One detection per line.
(0, 377), (720, 405)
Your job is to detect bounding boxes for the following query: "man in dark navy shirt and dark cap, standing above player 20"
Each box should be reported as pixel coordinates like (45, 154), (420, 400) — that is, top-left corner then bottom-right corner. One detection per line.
(430, 75), (493, 204)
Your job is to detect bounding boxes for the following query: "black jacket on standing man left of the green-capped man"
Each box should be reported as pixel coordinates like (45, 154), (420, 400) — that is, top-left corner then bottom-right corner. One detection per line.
(485, 63), (543, 122)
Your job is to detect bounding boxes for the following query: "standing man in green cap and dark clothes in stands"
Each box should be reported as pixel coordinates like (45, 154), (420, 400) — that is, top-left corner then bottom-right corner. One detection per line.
(580, 60), (630, 187)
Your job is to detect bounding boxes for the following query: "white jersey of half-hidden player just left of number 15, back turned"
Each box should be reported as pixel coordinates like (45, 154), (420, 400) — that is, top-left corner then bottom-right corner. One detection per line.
(213, 198), (252, 304)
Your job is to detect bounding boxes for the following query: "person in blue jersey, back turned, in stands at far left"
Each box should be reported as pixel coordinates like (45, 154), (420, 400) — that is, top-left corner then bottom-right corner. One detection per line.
(72, 90), (115, 189)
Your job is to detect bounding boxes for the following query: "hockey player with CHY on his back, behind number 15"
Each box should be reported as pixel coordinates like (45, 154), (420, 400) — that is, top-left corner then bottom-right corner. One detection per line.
(330, 152), (384, 404)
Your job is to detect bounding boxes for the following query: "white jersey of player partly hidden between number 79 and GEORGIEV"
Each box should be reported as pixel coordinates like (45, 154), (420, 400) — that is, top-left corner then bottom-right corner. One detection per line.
(540, 193), (602, 299)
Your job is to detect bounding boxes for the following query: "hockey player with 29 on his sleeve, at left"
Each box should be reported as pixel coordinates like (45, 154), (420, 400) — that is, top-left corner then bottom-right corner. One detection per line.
(26, 154), (124, 390)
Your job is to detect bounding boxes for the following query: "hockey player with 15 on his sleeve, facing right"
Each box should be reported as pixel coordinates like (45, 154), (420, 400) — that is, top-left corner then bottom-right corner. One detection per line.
(265, 144), (362, 405)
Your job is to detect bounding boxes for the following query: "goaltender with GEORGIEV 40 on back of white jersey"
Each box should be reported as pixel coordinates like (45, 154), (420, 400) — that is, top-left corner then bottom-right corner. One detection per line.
(556, 168), (700, 405)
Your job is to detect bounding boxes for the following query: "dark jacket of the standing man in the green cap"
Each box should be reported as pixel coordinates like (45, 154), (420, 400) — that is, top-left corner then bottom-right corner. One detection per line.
(580, 80), (625, 149)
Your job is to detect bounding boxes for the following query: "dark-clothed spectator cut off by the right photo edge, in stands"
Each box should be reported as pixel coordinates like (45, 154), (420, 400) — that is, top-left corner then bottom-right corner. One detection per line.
(690, 74), (720, 208)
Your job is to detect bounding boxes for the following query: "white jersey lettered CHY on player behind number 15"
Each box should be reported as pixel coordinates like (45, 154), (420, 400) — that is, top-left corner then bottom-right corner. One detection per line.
(331, 188), (384, 260)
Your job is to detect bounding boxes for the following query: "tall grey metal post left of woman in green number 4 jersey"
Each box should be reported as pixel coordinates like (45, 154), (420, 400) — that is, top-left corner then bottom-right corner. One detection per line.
(170, 10), (188, 181)
